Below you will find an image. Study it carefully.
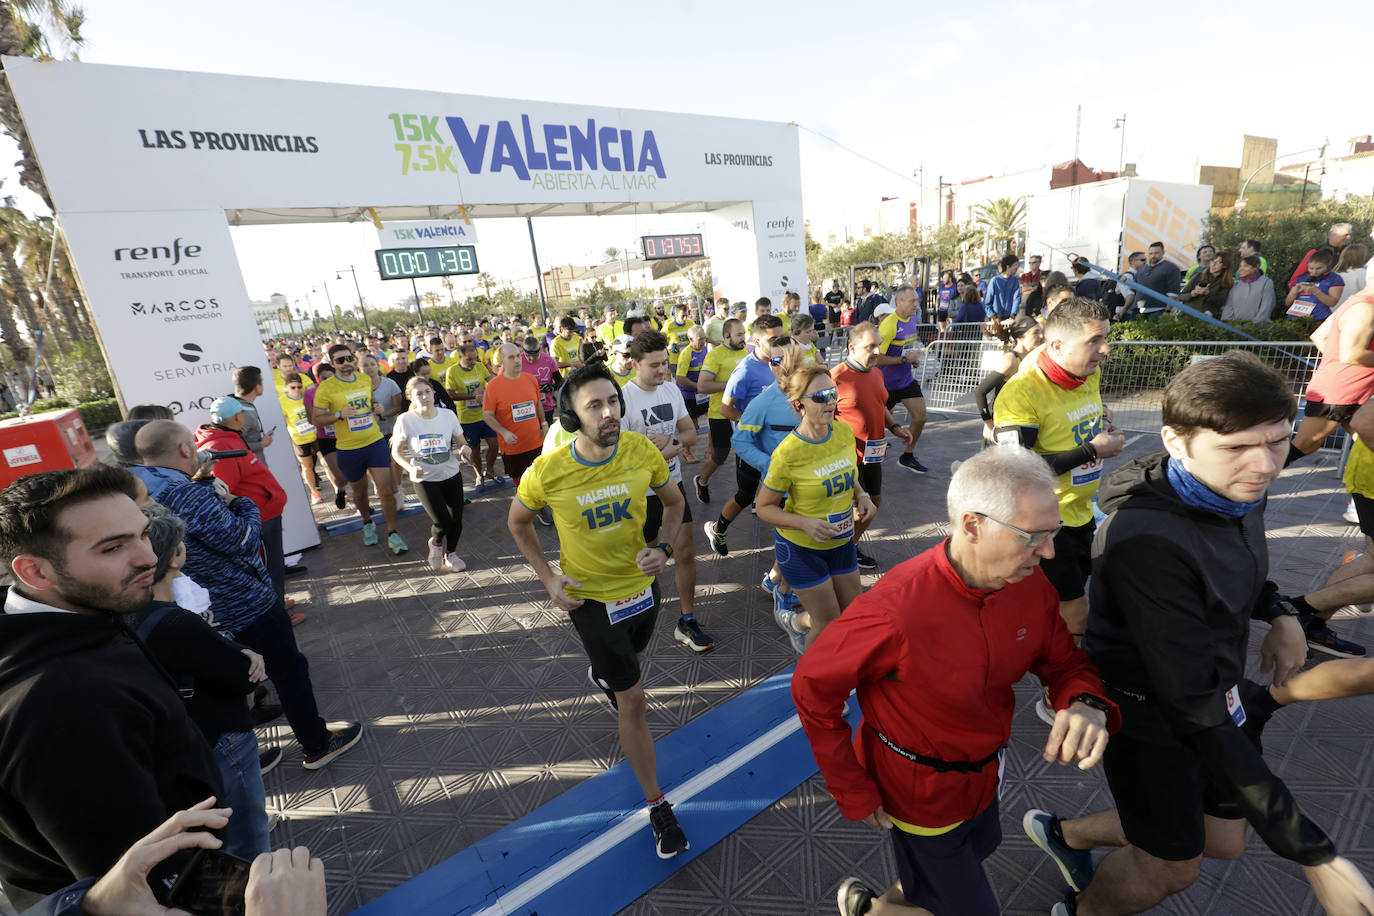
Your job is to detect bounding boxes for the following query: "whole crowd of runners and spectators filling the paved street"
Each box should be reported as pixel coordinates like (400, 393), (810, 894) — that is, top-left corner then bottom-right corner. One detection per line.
(0, 227), (1374, 916)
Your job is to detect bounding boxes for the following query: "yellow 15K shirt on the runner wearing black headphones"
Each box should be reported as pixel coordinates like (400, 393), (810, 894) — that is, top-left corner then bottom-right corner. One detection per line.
(515, 431), (670, 603)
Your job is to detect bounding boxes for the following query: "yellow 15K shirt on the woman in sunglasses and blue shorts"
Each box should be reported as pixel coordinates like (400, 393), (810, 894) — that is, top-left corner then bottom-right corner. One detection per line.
(764, 423), (859, 551)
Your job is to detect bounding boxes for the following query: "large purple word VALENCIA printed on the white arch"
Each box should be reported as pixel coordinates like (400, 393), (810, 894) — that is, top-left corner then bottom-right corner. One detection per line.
(448, 114), (665, 180)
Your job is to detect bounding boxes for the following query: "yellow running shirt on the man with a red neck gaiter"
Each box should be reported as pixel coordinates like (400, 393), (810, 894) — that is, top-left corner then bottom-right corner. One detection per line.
(992, 358), (1102, 527)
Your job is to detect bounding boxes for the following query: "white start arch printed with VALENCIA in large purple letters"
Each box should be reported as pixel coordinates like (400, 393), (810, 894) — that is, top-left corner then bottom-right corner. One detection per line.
(4, 58), (807, 551)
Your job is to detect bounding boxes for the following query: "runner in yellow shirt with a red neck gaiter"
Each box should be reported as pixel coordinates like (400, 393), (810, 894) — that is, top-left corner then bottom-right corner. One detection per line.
(993, 298), (1125, 694)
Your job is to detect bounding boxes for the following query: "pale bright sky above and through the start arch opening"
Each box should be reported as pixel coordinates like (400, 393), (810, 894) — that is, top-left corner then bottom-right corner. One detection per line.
(21, 0), (1374, 315)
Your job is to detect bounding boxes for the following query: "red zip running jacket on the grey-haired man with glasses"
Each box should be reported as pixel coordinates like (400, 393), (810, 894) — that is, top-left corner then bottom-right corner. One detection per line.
(791, 538), (1121, 828)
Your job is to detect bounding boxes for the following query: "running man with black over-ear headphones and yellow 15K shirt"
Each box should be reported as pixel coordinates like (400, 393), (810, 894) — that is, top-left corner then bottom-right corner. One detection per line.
(507, 364), (687, 858)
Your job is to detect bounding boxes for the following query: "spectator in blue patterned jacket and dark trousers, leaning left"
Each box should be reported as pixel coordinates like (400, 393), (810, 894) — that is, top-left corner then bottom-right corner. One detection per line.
(135, 420), (363, 769)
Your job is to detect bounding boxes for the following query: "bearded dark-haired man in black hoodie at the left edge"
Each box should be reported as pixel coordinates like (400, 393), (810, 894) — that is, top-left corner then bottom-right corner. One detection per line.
(0, 464), (223, 909)
